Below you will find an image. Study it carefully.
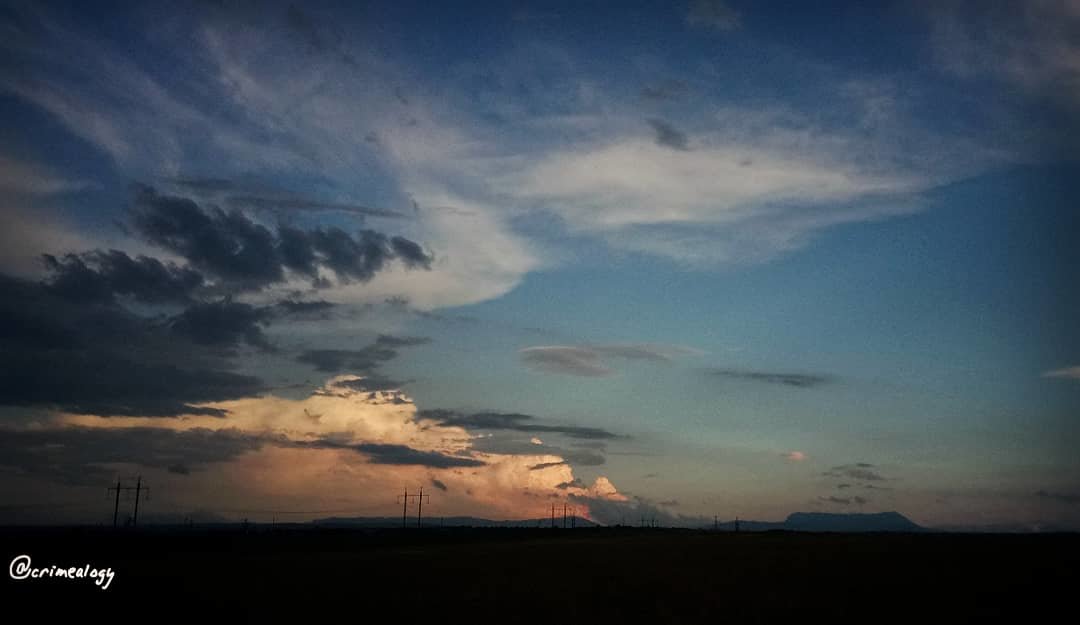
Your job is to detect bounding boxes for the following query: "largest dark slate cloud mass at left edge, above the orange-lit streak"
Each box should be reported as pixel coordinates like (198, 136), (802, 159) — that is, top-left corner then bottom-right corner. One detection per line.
(0, 274), (262, 417)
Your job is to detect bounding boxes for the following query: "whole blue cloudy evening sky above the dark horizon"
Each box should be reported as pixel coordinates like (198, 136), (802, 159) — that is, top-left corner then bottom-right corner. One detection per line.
(0, 0), (1080, 530)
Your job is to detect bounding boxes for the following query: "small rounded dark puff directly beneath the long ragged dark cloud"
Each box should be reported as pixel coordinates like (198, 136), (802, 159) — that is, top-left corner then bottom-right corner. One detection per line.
(171, 301), (273, 351)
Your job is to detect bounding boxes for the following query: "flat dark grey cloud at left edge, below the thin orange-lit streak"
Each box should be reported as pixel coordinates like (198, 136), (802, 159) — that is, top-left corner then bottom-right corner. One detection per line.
(0, 427), (265, 484)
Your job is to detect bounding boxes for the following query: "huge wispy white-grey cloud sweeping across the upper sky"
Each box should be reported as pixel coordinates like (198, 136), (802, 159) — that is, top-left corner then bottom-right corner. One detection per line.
(0, 1), (1007, 291)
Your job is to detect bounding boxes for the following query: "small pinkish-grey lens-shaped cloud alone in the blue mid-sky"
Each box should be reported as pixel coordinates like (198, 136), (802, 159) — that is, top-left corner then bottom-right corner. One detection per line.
(518, 343), (700, 378)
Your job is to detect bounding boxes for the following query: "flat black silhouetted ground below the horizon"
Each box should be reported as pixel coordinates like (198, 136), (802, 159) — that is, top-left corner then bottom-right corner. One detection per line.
(0, 528), (1080, 624)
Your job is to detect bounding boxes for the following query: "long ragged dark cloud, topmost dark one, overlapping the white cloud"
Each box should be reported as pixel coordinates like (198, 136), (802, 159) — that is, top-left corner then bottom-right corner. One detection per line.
(132, 186), (432, 290)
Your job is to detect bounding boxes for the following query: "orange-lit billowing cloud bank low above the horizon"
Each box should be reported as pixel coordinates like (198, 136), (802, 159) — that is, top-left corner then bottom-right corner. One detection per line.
(54, 376), (626, 520)
